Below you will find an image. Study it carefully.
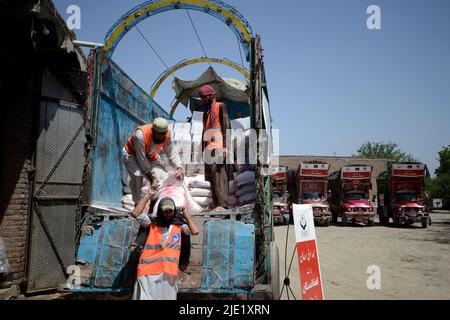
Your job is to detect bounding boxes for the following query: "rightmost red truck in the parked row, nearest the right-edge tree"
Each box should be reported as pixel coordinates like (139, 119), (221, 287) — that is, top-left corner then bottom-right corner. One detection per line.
(377, 163), (431, 228)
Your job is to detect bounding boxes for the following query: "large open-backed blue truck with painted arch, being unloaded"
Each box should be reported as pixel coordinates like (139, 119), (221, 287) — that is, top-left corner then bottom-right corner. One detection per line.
(67, 0), (279, 299)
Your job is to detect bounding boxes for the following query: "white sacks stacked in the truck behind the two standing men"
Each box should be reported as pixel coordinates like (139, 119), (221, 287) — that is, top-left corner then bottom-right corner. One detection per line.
(122, 112), (256, 213)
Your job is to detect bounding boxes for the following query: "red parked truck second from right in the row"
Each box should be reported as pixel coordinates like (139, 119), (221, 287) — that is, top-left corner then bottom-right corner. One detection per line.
(328, 165), (375, 227)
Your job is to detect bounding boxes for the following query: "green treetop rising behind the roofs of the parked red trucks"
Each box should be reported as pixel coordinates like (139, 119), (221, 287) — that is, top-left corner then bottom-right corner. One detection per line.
(353, 142), (418, 162)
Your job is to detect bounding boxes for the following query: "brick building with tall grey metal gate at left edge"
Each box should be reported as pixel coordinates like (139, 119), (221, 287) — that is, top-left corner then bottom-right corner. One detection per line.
(0, 0), (87, 298)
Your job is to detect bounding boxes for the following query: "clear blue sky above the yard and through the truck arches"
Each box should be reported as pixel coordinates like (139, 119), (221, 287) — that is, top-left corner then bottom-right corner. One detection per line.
(54, 0), (450, 172)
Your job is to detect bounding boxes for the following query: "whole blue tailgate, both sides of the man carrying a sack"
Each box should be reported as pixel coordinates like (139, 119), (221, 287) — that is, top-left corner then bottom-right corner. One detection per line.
(73, 205), (257, 293)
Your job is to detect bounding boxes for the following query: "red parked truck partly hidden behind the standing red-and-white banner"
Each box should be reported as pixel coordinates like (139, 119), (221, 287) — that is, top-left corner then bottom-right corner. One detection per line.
(297, 161), (331, 226)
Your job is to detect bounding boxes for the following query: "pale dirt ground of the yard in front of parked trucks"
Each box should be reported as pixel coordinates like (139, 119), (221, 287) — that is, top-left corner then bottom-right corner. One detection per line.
(275, 211), (450, 300)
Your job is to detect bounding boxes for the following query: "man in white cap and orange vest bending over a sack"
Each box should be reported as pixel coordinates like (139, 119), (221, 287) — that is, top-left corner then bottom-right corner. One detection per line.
(122, 118), (184, 204)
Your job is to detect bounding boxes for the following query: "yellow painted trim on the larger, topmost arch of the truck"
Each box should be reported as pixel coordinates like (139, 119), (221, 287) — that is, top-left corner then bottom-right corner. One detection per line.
(104, 0), (251, 52)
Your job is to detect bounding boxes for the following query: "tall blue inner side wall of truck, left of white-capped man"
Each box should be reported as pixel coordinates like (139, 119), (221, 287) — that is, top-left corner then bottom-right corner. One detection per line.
(90, 59), (169, 208)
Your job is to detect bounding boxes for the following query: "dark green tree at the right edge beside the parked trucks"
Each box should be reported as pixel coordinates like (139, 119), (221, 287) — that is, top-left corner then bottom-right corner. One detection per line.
(426, 145), (450, 209)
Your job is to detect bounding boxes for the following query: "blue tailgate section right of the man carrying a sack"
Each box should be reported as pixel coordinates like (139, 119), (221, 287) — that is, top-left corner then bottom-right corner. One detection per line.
(179, 206), (255, 293)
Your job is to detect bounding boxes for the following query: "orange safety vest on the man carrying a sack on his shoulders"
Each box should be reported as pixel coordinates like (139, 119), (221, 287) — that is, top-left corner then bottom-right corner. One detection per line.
(137, 224), (181, 277)
